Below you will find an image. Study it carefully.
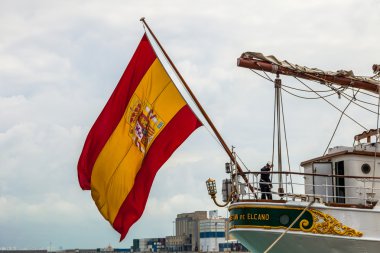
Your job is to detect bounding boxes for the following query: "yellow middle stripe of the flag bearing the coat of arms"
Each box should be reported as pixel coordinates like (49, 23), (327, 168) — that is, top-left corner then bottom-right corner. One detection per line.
(91, 59), (186, 223)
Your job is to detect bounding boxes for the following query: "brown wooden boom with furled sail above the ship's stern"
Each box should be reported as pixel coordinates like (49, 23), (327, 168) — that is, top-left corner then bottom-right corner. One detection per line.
(237, 57), (379, 93)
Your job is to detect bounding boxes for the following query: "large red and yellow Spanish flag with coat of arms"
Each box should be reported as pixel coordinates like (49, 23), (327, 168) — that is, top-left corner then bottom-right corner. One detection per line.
(78, 34), (202, 240)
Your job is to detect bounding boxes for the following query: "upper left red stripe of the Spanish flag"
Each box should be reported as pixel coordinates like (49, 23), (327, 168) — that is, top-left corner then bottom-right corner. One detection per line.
(78, 34), (156, 190)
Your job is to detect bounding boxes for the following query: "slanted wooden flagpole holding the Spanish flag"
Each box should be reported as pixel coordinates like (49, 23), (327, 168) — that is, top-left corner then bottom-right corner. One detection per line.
(140, 17), (254, 196)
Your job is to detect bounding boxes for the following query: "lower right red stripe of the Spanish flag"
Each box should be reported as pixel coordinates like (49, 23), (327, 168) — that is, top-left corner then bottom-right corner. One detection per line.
(113, 105), (202, 241)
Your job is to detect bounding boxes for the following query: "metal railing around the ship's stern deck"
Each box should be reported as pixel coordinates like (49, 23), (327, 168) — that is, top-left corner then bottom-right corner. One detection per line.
(235, 172), (380, 206)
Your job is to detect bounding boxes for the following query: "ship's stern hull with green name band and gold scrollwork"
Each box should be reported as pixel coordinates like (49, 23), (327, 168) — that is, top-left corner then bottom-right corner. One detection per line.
(229, 202), (380, 253)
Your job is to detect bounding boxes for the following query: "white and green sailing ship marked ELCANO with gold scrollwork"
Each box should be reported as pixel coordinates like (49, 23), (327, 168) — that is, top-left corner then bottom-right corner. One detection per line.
(206, 52), (380, 253)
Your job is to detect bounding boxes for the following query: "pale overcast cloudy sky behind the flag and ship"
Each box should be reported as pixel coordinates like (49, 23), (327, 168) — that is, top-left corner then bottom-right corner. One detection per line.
(0, 0), (380, 249)
